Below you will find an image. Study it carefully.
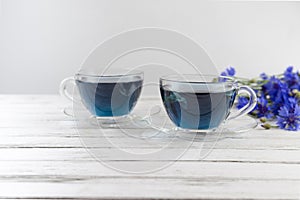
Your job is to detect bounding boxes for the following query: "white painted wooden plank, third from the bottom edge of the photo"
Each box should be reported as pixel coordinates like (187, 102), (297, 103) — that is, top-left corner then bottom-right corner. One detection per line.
(0, 148), (300, 164)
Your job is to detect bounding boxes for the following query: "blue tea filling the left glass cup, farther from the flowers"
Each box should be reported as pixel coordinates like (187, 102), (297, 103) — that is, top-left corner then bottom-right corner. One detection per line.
(76, 78), (143, 117)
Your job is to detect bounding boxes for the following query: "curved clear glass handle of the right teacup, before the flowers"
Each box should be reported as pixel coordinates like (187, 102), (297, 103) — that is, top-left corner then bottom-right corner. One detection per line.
(227, 86), (257, 120)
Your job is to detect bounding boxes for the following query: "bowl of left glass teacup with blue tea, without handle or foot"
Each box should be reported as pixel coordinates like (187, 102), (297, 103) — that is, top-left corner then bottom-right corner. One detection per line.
(75, 72), (143, 119)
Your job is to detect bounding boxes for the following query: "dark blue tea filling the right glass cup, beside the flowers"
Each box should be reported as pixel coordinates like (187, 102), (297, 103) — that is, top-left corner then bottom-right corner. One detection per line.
(160, 86), (237, 130)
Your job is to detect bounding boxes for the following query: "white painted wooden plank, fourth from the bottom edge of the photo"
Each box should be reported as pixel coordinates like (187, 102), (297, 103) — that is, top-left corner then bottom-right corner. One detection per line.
(0, 133), (300, 150)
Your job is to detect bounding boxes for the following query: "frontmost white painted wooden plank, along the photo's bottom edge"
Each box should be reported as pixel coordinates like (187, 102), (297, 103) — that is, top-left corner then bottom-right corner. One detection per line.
(0, 177), (300, 200)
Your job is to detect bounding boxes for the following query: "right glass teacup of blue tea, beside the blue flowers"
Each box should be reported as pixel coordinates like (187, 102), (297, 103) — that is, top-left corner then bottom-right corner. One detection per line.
(160, 74), (257, 133)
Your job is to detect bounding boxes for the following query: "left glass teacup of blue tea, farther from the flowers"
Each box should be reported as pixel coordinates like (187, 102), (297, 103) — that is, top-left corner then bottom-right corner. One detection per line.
(60, 71), (144, 127)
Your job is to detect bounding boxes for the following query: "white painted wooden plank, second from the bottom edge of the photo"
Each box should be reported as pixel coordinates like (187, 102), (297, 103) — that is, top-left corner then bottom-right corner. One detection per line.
(0, 160), (300, 182)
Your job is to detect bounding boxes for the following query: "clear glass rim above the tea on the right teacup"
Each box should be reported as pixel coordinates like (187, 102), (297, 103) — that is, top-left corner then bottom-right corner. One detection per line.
(160, 74), (237, 84)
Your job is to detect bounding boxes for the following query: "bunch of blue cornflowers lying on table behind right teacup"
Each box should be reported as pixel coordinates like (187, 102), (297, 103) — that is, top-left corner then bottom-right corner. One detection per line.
(221, 66), (300, 131)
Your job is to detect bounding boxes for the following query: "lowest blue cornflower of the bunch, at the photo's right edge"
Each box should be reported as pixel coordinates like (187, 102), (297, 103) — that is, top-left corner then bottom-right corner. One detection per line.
(277, 97), (300, 131)
